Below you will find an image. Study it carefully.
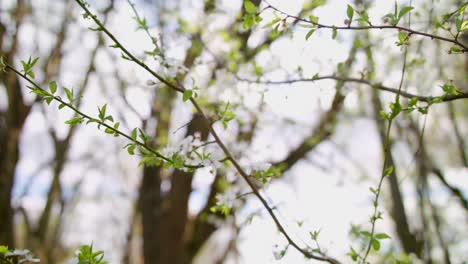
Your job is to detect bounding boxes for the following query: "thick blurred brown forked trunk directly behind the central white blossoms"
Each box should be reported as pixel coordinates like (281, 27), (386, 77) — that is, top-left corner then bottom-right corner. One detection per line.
(140, 21), (205, 263)
